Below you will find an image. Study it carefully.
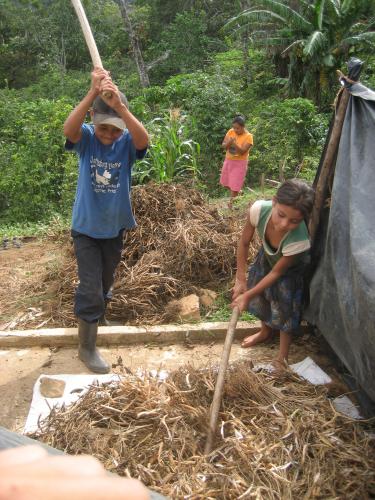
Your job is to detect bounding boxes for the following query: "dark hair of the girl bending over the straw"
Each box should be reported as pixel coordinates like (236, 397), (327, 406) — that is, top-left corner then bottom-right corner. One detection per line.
(275, 179), (315, 220)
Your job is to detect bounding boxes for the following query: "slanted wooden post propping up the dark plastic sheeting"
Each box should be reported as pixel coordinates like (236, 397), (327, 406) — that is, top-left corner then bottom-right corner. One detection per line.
(309, 88), (350, 242)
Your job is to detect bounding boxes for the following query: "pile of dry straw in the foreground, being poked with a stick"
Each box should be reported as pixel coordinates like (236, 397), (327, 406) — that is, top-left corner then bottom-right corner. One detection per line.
(34, 364), (375, 500)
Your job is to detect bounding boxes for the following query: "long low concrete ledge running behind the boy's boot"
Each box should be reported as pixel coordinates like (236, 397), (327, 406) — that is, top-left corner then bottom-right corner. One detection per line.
(0, 321), (260, 348)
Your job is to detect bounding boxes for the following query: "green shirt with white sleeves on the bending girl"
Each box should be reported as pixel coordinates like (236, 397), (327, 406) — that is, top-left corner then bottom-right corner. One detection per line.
(250, 200), (310, 267)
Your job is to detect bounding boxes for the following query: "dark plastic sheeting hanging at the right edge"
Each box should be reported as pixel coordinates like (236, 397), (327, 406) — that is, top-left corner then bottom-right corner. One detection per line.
(304, 68), (375, 401)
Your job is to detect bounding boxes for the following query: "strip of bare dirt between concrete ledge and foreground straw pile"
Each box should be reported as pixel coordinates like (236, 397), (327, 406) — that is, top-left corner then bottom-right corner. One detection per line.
(0, 336), (346, 432)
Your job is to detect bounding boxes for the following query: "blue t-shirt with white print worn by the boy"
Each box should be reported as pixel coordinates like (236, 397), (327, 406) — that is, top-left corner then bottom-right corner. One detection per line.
(65, 123), (146, 239)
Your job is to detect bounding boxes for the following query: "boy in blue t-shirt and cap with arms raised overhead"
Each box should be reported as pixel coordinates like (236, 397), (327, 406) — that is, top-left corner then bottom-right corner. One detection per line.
(64, 68), (148, 373)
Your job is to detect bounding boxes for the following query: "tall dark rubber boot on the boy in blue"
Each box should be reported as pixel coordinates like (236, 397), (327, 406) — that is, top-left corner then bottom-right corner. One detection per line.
(78, 318), (110, 373)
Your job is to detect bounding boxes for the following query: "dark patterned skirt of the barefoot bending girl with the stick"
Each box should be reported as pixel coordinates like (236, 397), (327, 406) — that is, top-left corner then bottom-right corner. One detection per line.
(247, 247), (304, 334)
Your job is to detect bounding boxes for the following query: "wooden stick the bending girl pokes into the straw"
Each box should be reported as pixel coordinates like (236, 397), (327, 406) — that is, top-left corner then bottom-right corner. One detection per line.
(204, 307), (240, 455)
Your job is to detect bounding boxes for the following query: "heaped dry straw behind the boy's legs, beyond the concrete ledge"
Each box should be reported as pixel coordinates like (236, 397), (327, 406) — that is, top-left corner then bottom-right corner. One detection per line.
(29, 183), (256, 327)
